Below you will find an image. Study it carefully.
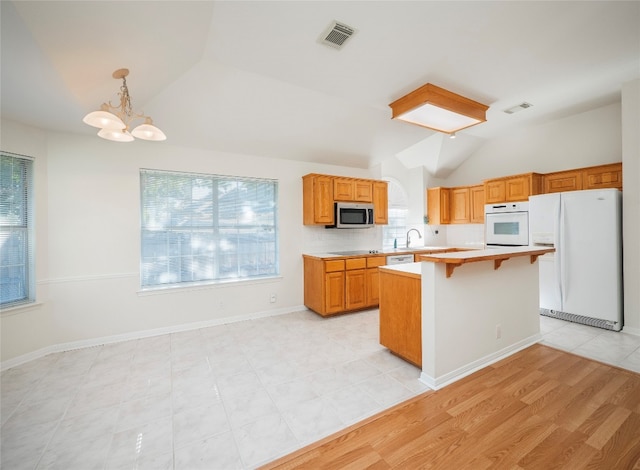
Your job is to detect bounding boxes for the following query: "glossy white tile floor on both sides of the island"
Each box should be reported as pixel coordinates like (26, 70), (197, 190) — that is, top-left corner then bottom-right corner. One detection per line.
(0, 310), (640, 470)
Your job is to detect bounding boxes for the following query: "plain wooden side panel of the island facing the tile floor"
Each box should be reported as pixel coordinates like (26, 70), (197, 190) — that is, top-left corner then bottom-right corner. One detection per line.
(380, 270), (422, 367)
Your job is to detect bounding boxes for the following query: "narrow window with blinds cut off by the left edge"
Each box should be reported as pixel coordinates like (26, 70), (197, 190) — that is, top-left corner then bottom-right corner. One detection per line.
(0, 152), (35, 308)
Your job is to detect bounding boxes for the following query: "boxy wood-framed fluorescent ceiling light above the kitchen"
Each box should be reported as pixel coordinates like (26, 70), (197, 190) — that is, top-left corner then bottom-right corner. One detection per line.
(389, 83), (489, 134)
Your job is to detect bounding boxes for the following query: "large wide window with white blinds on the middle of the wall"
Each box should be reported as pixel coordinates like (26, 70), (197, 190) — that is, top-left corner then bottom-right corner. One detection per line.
(140, 170), (279, 288)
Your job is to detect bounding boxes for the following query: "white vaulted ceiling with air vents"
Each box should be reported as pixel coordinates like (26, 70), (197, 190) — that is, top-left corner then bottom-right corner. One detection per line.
(1, 0), (640, 176)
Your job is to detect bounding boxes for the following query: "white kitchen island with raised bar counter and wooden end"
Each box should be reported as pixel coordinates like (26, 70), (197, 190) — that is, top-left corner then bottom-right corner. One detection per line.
(379, 246), (554, 389)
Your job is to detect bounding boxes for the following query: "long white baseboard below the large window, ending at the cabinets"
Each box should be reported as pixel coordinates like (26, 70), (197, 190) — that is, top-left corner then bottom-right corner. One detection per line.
(0, 305), (307, 371)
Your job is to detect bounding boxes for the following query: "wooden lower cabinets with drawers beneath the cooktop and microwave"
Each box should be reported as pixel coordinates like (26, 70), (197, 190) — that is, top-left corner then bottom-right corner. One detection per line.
(304, 256), (386, 316)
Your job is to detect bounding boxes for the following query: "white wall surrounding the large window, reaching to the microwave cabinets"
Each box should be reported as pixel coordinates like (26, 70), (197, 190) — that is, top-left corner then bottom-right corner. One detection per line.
(0, 121), (381, 362)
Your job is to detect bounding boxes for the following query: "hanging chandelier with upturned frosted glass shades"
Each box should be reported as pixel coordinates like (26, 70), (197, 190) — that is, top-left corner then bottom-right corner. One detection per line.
(82, 69), (167, 142)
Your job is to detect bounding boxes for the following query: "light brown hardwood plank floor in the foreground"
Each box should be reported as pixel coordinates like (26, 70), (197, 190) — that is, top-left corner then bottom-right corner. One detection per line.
(262, 344), (640, 470)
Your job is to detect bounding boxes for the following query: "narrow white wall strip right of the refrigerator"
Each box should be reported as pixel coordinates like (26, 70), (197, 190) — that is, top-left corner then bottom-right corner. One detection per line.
(622, 80), (640, 335)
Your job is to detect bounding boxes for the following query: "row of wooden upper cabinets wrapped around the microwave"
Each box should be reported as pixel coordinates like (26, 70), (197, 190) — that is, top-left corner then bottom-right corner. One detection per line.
(302, 173), (388, 226)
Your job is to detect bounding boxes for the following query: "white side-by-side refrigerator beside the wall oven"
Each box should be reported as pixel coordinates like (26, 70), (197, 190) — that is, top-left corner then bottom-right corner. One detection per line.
(529, 189), (623, 331)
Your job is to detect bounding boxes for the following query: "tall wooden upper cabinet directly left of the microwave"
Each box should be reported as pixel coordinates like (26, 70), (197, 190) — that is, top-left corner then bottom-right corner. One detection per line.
(302, 175), (334, 225)
